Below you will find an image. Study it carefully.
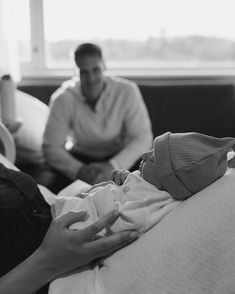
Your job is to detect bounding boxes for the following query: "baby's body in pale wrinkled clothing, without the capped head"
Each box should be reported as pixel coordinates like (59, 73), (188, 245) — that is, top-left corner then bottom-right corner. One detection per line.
(53, 171), (179, 234)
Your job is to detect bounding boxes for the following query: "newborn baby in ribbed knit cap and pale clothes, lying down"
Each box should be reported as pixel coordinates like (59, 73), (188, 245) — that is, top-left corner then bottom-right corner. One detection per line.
(52, 132), (235, 234)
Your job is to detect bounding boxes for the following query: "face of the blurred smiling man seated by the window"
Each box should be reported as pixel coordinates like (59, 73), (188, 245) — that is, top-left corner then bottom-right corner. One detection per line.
(77, 55), (105, 102)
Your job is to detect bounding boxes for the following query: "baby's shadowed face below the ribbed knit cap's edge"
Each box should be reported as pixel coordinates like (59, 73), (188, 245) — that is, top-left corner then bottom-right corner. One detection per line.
(140, 150), (162, 189)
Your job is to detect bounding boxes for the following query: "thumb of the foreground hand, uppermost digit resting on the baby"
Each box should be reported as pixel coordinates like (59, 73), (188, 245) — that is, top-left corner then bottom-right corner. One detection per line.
(57, 210), (89, 228)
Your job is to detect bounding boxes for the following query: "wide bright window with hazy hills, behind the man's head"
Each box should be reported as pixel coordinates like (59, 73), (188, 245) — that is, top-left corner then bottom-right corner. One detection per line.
(18, 0), (235, 74)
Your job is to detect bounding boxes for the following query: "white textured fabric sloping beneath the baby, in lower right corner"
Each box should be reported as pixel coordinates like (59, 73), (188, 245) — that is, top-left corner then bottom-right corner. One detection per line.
(49, 170), (235, 294)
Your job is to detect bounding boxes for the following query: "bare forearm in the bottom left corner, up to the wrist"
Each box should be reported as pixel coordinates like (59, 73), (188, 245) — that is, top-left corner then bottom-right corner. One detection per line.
(0, 249), (54, 294)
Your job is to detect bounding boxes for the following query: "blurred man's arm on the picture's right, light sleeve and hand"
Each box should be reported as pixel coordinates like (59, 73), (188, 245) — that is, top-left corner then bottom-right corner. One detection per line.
(89, 83), (153, 184)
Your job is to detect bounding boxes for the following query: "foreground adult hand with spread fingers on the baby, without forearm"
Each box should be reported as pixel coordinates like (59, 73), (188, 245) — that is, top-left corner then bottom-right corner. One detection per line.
(38, 211), (137, 278)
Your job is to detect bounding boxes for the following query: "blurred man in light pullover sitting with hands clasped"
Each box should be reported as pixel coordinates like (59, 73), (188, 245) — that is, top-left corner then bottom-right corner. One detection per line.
(39, 43), (152, 190)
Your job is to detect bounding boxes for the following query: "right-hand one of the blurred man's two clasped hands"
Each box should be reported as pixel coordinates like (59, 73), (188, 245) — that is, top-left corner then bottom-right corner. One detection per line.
(89, 161), (113, 184)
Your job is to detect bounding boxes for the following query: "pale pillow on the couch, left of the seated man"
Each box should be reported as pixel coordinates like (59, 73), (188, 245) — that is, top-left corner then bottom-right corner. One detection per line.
(14, 90), (49, 164)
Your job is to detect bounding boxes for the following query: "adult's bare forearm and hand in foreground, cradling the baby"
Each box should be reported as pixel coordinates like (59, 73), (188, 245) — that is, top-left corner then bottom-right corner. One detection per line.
(0, 211), (137, 294)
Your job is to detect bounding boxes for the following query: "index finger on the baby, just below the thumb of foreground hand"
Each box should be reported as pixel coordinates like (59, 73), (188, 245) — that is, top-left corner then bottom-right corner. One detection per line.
(79, 210), (119, 241)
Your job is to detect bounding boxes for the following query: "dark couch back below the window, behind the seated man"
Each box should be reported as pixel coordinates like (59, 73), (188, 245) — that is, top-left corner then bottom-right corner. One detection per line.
(19, 83), (235, 137)
